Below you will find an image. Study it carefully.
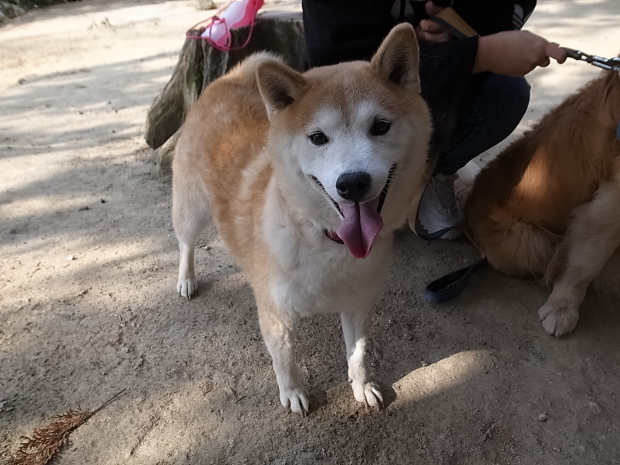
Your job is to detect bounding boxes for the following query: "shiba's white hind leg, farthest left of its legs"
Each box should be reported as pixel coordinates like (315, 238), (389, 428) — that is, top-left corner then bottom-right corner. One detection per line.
(172, 172), (211, 300)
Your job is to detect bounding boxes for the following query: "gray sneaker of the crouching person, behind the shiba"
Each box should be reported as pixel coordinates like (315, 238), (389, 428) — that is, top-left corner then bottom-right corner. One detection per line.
(418, 174), (464, 240)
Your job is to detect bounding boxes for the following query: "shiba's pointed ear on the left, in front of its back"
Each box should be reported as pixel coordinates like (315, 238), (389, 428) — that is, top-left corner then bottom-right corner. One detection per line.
(256, 60), (306, 118)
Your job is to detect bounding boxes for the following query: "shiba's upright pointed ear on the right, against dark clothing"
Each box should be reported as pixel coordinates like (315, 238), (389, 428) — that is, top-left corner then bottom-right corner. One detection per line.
(370, 23), (420, 94)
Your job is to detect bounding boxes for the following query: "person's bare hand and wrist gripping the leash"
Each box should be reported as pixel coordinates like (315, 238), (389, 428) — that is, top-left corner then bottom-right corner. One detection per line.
(473, 31), (566, 76)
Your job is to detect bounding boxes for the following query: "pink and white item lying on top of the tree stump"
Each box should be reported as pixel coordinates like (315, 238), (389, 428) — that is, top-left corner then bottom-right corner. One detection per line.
(200, 0), (264, 51)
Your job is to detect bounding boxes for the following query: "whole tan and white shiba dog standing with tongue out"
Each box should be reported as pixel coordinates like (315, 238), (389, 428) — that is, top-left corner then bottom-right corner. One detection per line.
(173, 25), (431, 415)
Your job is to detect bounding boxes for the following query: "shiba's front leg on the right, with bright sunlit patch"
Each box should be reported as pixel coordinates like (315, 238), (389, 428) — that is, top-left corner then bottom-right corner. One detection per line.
(340, 309), (383, 408)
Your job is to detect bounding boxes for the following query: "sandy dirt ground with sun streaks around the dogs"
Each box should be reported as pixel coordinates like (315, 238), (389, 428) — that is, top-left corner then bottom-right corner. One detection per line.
(0, 0), (620, 465)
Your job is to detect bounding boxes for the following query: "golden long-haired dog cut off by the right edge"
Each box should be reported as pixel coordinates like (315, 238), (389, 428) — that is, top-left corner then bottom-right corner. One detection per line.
(465, 71), (620, 336)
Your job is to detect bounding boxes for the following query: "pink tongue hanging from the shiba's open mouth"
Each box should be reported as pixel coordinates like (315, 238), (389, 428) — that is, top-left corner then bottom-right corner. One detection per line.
(336, 198), (383, 258)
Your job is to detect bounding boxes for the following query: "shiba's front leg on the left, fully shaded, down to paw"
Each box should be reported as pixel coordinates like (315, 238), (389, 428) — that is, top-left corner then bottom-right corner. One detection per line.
(258, 303), (310, 417)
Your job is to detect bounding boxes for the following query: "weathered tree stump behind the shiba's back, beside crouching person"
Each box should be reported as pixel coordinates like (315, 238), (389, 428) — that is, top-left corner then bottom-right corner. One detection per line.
(144, 12), (305, 173)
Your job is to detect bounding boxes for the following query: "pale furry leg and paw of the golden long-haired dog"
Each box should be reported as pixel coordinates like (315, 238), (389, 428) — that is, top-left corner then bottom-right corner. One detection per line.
(538, 169), (620, 336)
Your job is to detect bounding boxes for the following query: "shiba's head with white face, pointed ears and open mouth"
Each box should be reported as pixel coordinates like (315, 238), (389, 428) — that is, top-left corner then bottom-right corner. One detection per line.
(256, 24), (430, 258)
